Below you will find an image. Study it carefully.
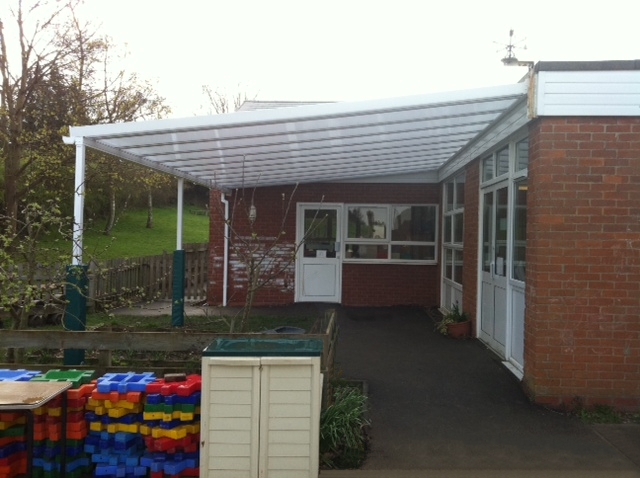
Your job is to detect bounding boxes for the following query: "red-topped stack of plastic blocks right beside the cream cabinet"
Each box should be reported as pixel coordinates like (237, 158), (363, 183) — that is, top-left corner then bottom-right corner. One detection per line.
(140, 374), (202, 478)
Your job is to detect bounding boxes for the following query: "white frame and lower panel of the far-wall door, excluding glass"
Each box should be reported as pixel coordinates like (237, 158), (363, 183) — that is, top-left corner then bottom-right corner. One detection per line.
(295, 203), (343, 303)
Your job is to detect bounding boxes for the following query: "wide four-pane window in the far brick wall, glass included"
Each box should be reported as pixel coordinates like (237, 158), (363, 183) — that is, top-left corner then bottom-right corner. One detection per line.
(345, 204), (437, 262)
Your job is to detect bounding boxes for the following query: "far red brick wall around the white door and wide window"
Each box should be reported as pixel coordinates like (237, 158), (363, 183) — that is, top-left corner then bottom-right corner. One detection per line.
(208, 184), (439, 306)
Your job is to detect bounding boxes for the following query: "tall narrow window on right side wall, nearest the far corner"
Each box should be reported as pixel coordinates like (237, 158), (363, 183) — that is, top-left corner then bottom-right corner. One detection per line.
(442, 174), (465, 288)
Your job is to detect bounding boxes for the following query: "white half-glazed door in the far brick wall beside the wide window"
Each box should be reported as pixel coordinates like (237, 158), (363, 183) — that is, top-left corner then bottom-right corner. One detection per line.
(296, 204), (342, 302)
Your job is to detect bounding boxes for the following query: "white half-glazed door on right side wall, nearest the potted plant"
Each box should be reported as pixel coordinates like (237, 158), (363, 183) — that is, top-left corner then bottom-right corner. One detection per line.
(480, 185), (509, 357)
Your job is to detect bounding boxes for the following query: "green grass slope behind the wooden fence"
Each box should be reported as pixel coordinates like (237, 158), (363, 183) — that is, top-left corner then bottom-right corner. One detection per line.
(53, 207), (209, 261)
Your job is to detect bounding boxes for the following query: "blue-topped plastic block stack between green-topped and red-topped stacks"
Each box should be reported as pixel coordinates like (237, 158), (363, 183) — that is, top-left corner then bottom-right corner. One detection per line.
(85, 372), (156, 478)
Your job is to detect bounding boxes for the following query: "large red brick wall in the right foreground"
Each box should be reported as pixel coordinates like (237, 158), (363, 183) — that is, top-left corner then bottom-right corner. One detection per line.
(524, 118), (640, 409)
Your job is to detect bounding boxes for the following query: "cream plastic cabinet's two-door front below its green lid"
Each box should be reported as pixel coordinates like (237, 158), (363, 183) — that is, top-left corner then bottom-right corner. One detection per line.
(200, 356), (322, 478)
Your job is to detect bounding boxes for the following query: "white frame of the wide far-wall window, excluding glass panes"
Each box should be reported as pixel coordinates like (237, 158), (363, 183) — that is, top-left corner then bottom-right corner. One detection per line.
(342, 203), (439, 265)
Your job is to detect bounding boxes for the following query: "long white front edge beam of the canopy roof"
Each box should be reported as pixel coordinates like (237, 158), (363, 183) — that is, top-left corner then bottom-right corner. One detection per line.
(69, 83), (526, 137)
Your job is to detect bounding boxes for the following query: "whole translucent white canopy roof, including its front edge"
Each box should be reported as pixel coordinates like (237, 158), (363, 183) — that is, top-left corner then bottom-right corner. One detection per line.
(70, 83), (527, 190)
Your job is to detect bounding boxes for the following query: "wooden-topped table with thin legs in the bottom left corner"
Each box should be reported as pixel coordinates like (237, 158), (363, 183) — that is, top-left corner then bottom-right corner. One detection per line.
(0, 382), (73, 476)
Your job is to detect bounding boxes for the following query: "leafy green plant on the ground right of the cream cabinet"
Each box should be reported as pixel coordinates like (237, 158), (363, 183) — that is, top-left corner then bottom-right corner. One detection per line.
(320, 384), (370, 469)
